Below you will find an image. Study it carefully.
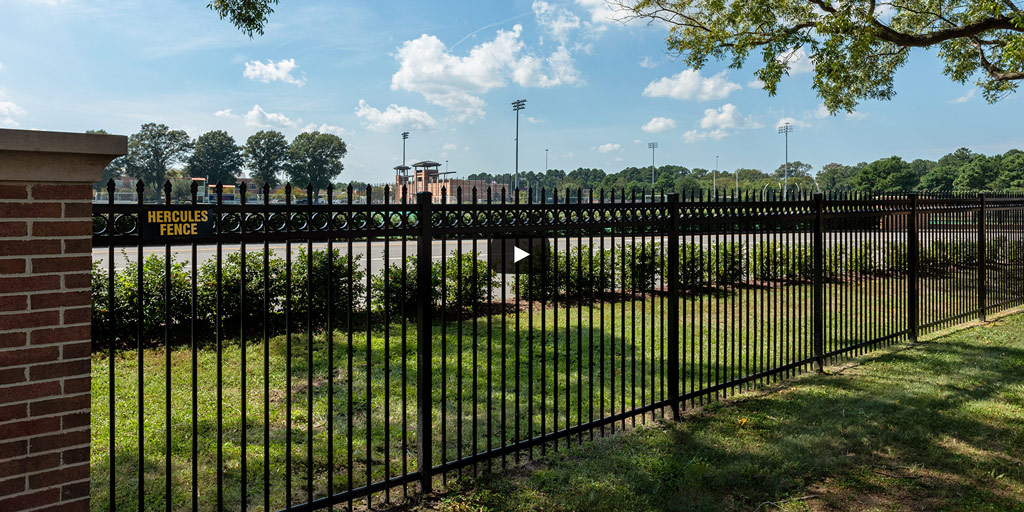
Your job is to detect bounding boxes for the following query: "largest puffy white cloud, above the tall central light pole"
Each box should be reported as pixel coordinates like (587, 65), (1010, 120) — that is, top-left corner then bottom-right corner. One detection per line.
(391, 25), (581, 121)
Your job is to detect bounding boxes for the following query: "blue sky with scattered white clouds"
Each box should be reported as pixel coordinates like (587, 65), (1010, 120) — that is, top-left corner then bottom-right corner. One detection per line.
(0, 0), (1024, 182)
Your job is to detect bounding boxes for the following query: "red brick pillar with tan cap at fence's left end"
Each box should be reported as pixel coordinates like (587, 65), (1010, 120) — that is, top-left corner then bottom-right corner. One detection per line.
(0, 129), (127, 511)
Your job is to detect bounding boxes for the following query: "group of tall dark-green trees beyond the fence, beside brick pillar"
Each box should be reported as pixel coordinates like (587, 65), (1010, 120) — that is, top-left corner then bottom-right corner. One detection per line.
(97, 123), (348, 199)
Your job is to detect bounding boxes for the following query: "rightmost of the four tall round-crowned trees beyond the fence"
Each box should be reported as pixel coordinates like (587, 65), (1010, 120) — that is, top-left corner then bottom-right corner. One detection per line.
(286, 131), (348, 195)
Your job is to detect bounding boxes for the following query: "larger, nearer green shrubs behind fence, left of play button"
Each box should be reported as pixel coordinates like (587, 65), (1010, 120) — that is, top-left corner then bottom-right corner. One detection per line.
(92, 248), (499, 348)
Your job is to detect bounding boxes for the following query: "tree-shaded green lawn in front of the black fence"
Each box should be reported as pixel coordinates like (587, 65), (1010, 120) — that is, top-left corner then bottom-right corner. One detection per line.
(432, 307), (1024, 512)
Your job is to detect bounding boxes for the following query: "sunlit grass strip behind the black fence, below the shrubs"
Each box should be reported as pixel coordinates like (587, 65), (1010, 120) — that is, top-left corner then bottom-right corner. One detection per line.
(91, 278), (1019, 510)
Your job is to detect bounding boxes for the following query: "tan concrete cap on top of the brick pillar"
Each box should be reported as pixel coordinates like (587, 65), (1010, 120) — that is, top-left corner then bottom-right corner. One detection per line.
(0, 129), (128, 183)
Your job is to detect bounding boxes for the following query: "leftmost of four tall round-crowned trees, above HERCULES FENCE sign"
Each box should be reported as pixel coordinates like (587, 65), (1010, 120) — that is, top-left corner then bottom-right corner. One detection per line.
(126, 123), (193, 197)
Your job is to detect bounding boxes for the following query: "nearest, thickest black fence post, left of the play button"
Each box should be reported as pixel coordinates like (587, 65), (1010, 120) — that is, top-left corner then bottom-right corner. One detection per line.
(416, 191), (433, 494)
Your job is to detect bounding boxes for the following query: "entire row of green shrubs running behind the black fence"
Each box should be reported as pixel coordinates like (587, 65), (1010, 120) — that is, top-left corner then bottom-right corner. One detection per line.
(92, 237), (1024, 347)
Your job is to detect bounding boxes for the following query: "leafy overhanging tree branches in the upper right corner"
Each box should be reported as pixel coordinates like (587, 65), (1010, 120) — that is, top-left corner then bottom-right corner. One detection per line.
(613, 0), (1024, 113)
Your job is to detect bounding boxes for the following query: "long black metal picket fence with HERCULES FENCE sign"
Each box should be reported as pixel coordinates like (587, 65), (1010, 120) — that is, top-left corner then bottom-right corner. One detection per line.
(91, 183), (1024, 510)
